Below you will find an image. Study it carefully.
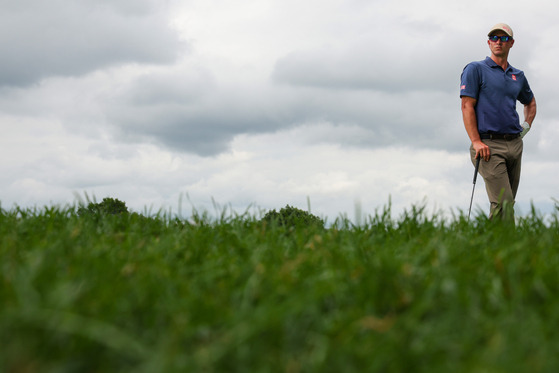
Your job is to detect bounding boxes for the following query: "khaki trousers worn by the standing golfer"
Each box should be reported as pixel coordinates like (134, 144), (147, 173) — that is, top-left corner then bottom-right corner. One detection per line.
(470, 138), (524, 219)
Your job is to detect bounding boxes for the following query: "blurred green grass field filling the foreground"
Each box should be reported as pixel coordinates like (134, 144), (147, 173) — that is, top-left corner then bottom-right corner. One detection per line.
(0, 203), (559, 373)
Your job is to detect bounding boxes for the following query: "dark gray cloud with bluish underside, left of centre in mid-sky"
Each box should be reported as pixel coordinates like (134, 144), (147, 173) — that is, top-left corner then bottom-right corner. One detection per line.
(103, 64), (294, 156)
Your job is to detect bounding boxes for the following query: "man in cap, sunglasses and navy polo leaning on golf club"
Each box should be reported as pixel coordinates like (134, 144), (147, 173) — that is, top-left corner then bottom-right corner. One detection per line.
(460, 23), (536, 220)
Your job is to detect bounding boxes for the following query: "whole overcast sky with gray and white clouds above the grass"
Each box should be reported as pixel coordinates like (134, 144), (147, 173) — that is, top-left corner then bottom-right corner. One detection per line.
(0, 0), (559, 221)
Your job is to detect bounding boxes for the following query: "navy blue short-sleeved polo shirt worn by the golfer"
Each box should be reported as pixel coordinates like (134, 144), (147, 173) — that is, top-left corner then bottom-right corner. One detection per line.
(460, 57), (534, 134)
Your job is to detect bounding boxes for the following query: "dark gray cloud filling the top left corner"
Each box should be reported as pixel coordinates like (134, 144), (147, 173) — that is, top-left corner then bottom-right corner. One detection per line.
(0, 0), (183, 86)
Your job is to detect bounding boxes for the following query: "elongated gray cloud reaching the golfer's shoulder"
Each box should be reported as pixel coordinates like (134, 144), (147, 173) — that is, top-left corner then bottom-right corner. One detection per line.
(273, 34), (482, 93)
